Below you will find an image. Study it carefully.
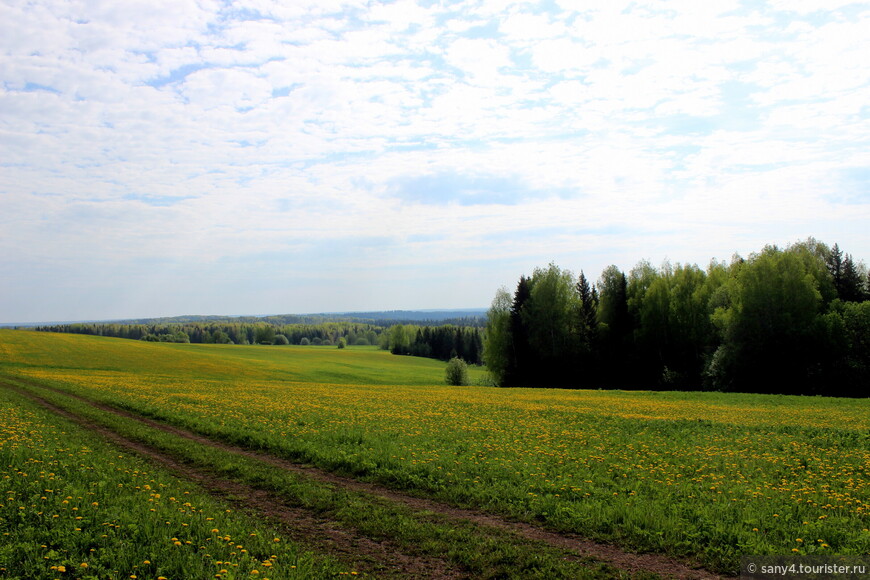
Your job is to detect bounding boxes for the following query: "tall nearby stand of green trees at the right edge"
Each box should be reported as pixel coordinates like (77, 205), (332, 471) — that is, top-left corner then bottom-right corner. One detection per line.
(484, 238), (870, 397)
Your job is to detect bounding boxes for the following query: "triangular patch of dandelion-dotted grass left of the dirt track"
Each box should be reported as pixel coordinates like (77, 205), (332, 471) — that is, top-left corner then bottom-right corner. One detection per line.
(0, 389), (349, 580)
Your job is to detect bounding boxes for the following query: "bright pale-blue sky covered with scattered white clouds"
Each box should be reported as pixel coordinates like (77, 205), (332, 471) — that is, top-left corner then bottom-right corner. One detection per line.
(0, 0), (870, 322)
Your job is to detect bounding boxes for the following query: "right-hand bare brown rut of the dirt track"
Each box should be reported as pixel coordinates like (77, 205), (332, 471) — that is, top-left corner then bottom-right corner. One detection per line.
(17, 381), (731, 580)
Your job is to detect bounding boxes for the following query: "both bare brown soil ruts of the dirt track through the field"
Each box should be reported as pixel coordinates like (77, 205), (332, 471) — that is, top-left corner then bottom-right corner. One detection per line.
(10, 384), (727, 580)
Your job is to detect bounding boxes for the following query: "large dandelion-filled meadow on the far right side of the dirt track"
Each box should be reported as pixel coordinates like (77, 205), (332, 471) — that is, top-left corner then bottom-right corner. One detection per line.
(0, 331), (870, 573)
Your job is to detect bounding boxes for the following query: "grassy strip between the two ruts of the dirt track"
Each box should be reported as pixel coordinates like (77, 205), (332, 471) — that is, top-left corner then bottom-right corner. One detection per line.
(10, 386), (622, 579)
